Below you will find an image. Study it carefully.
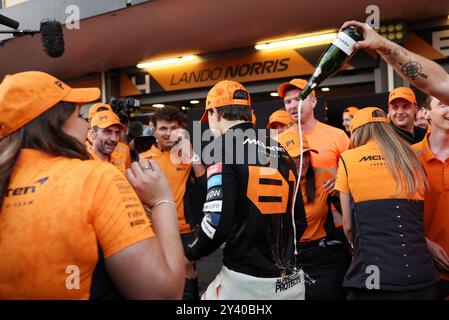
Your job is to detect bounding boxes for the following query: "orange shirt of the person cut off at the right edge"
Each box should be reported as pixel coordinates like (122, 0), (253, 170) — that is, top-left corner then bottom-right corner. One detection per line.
(412, 132), (449, 280)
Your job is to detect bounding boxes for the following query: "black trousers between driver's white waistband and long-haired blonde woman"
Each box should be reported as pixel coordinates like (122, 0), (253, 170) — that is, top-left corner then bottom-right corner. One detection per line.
(298, 245), (351, 300)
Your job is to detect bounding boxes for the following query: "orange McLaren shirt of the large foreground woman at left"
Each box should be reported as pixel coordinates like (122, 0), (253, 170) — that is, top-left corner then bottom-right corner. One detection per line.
(0, 149), (154, 299)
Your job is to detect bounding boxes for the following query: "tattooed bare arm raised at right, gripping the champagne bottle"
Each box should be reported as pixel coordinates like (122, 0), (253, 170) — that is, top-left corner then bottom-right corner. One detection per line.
(342, 21), (449, 104)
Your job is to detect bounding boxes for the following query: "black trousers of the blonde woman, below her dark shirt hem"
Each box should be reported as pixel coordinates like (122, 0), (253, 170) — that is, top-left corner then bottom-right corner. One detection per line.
(348, 286), (438, 300)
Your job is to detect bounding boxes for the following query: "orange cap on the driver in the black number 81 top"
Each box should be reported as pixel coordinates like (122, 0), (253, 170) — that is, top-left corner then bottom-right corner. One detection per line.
(201, 80), (251, 122)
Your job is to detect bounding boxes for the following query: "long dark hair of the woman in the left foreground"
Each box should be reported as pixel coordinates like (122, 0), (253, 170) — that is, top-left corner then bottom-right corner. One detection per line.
(0, 102), (91, 208)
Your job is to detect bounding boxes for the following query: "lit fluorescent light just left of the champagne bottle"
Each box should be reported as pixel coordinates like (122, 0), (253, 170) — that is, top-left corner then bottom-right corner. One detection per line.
(255, 32), (337, 50)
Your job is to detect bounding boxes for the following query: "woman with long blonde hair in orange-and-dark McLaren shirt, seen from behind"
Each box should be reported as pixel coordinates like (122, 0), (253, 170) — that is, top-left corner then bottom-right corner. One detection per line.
(335, 108), (437, 299)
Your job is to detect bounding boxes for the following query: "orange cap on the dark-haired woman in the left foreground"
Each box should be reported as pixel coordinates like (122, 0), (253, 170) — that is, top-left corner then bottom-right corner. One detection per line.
(0, 71), (100, 139)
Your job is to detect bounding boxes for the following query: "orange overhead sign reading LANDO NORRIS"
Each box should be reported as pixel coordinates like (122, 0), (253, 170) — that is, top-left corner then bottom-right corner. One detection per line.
(142, 50), (315, 91)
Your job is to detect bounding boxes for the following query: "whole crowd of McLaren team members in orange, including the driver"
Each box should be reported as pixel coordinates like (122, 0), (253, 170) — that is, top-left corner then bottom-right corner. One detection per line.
(0, 21), (449, 300)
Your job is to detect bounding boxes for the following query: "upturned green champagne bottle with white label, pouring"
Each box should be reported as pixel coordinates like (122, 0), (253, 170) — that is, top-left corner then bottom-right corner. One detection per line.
(299, 27), (363, 100)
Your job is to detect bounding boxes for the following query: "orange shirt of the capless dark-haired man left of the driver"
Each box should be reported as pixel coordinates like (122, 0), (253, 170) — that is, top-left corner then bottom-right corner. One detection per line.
(139, 146), (192, 234)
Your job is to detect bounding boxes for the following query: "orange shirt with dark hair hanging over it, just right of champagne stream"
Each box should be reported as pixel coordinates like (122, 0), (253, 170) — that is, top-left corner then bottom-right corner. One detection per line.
(300, 173), (328, 242)
